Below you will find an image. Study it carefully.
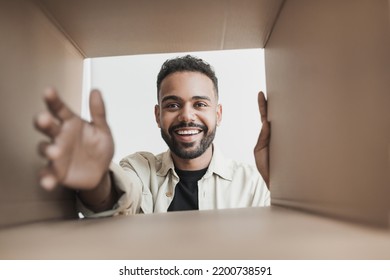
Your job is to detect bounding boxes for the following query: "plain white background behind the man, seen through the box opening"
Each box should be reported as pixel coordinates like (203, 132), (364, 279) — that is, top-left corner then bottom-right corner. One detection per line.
(82, 49), (266, 164)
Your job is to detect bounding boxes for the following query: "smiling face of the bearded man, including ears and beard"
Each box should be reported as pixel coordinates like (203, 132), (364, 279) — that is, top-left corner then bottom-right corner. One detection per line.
(155, 72), (222, 159)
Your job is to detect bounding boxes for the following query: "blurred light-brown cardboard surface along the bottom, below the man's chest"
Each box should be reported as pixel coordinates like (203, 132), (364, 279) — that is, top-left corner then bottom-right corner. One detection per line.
(0, 206), (390, 260)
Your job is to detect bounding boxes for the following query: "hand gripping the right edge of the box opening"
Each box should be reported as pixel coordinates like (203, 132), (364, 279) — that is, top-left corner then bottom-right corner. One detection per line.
(254, 92), (271, 189)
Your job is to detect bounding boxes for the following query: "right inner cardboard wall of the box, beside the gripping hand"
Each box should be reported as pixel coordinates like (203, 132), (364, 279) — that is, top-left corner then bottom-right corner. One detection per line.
(265, 0), (390, 225)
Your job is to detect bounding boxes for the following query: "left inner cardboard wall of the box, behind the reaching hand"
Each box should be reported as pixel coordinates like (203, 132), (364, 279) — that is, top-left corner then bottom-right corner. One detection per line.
(0, 0), (83, 227)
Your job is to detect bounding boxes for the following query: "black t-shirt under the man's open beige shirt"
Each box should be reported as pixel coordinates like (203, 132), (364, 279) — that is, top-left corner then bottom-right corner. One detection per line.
(168, 168), (207, 211)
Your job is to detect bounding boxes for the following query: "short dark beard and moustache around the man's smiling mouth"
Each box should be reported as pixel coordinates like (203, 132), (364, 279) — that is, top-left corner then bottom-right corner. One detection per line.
(161, 123), (217, 159)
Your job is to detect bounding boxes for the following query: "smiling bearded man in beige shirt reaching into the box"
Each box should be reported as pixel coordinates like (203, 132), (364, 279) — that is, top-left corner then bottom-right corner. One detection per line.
(35, 56), (270, 217)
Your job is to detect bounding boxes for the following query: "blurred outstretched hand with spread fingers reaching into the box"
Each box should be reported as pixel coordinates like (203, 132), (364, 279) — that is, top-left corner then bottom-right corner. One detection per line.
(35, 89), (114, 190)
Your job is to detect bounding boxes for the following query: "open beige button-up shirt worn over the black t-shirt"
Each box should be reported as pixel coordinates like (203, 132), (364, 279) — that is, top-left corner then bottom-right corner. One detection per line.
(78, 146), (270, 217)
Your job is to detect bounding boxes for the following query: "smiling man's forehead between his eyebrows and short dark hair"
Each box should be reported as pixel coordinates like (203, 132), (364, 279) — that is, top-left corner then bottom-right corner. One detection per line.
(159, 71), (216, 102)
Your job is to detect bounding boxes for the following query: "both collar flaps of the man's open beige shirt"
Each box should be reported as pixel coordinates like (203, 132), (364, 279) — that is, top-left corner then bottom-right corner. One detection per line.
(157, 144), (234, 181)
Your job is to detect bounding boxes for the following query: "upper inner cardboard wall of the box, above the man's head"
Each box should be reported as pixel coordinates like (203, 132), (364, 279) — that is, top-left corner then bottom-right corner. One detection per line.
(38, 0), (283, 57)
